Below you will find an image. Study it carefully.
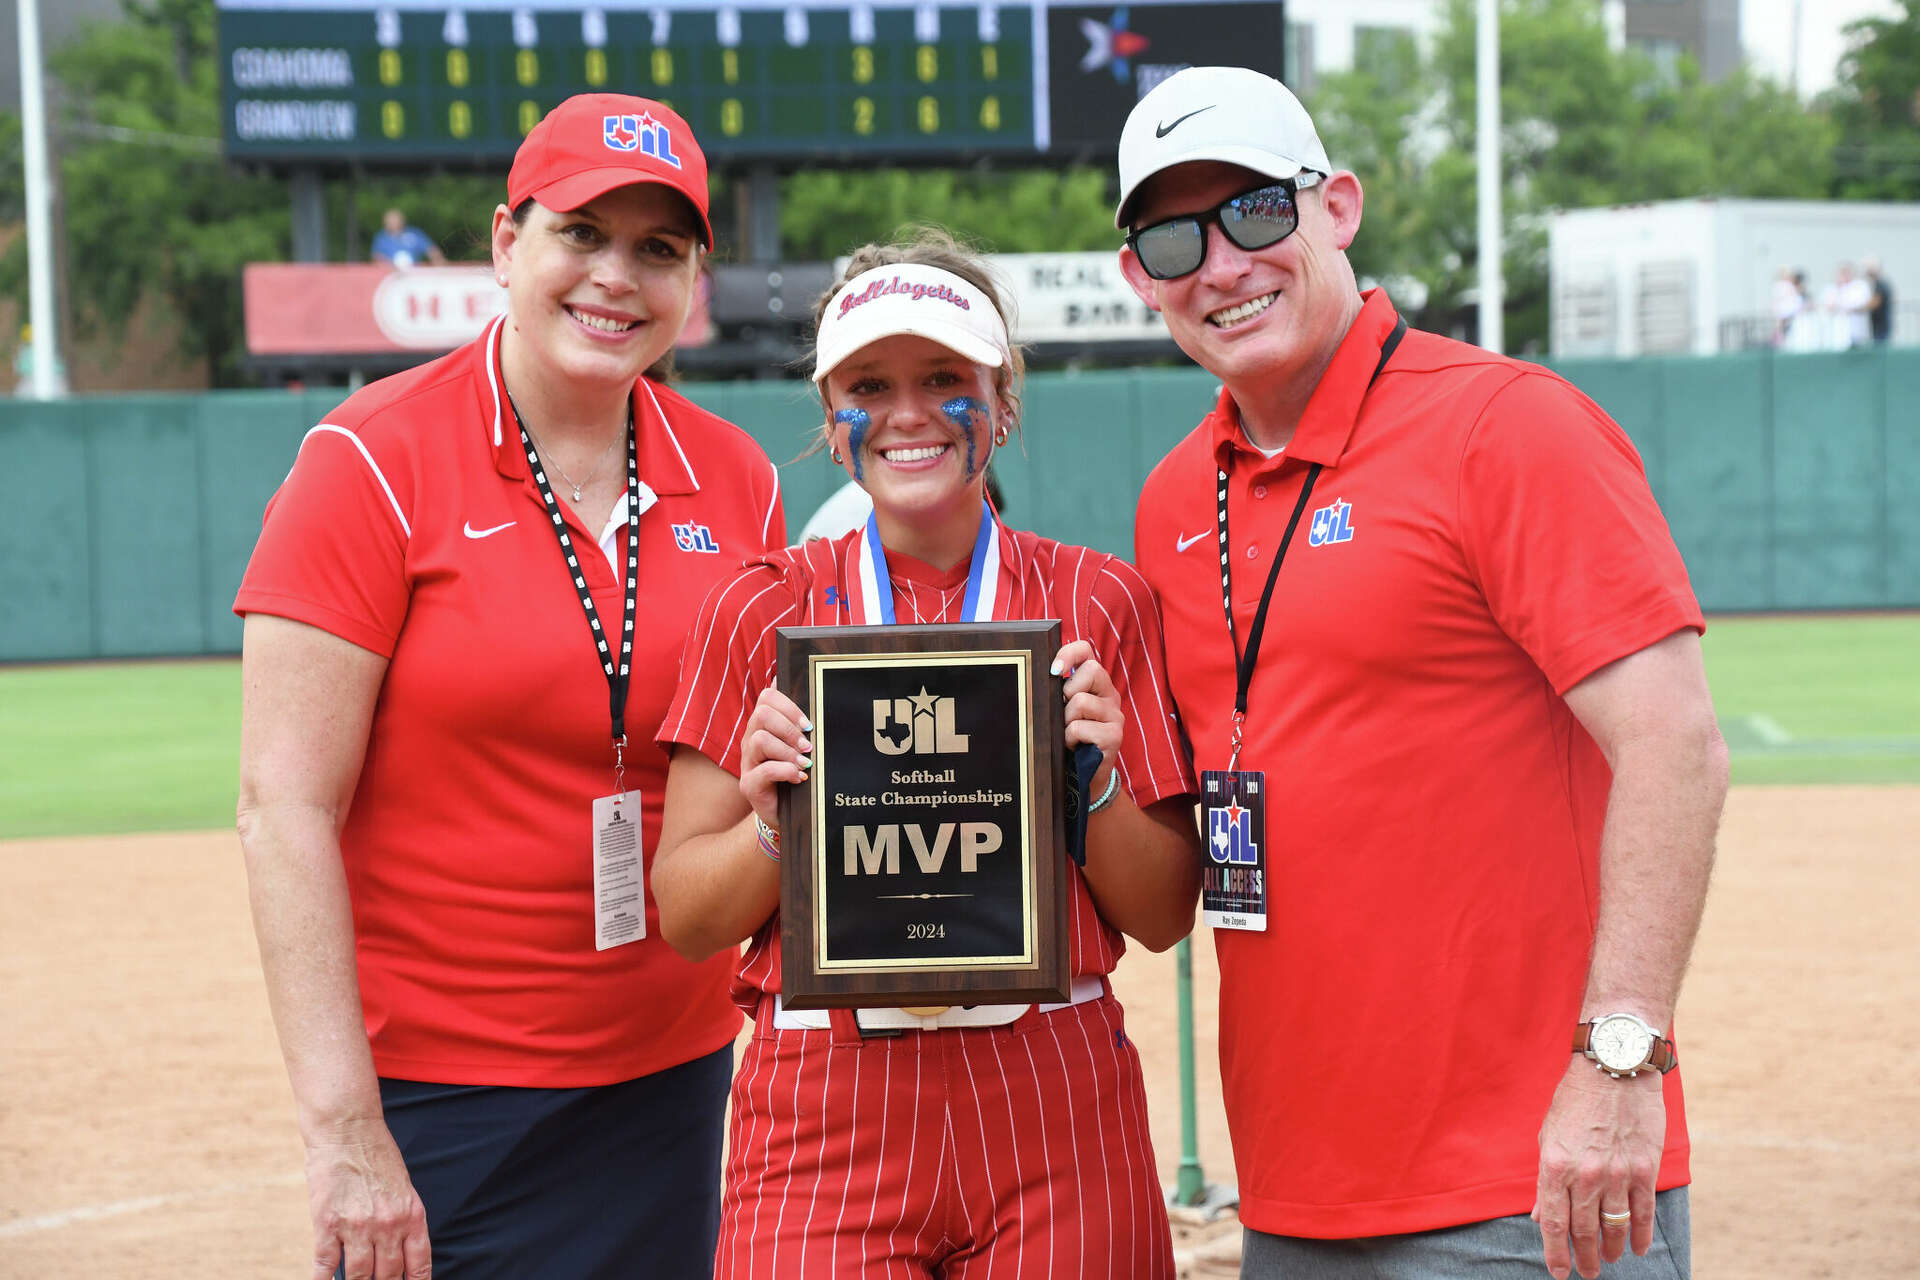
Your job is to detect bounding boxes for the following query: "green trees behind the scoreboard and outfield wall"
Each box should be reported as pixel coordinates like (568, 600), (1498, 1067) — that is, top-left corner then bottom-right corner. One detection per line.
(0, 0), (1920, 386)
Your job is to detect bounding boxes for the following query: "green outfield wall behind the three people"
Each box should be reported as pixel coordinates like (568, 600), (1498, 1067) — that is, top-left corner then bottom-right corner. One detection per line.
(0, 349), (1920, 660)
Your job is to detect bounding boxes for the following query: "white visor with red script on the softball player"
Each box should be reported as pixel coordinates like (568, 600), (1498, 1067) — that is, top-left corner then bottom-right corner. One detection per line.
(814, 263), (1010, 384)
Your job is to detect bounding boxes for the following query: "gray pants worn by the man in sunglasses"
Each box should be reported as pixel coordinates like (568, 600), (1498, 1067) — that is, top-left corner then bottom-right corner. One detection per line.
(1240, 1186), (1693, 1280)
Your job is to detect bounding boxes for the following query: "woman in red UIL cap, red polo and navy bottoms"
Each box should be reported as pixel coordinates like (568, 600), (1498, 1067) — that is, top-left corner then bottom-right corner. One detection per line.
(234, 94), (785, 1280)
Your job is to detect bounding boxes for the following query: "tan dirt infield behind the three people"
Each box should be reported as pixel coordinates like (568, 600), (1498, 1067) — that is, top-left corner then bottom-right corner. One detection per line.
(0, 787), (1920, 1280)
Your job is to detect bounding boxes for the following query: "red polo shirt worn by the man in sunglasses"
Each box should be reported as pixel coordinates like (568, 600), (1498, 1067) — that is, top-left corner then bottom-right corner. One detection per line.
(1135, 292), (1703, 1238)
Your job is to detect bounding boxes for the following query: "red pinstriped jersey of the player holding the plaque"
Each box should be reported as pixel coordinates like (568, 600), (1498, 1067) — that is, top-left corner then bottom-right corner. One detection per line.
(659, 526), (1194, 1009)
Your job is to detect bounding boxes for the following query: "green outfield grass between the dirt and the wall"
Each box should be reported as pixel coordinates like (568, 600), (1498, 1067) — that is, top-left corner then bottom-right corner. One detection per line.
(0, 614), (1920, 839)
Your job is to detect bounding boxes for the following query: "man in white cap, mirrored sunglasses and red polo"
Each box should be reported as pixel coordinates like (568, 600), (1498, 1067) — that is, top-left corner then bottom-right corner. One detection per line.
(1116, 67), (1726, 1280)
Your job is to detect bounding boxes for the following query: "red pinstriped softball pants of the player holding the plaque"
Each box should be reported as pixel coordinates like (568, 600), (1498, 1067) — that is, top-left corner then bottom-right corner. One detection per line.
(714, 996), (1173, 1280)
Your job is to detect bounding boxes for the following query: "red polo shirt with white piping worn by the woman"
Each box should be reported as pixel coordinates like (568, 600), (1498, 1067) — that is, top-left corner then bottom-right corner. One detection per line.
(234, 314), (785, 1088)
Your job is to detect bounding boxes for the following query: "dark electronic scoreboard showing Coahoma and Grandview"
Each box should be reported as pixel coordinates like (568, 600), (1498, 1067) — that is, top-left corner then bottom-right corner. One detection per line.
(215, 0), (1284, 165)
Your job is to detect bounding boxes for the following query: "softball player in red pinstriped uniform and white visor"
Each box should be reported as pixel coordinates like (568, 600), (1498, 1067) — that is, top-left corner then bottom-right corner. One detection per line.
(657, 234), (1200, 1280)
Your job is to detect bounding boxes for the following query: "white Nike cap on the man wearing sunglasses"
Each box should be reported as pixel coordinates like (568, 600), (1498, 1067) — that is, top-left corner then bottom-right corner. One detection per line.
(1114, 67), (1332, 230)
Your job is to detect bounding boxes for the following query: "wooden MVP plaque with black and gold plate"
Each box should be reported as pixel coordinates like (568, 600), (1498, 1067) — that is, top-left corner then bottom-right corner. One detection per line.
(776, 622), (1071, 1009)
